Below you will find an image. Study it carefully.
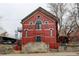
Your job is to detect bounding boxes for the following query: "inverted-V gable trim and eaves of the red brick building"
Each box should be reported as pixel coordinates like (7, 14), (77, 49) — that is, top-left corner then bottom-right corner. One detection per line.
(21, 7), (58, 23)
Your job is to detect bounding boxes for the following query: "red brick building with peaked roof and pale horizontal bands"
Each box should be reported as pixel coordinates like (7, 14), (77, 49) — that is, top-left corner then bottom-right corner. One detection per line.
(21, 7), (58, 48)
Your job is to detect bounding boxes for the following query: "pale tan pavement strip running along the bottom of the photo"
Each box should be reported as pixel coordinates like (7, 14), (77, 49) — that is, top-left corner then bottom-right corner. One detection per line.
(2, 52), (79, 56)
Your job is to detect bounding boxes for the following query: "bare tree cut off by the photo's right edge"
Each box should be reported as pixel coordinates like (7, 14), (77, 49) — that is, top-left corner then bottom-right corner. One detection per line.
(66, 3), (79, 32)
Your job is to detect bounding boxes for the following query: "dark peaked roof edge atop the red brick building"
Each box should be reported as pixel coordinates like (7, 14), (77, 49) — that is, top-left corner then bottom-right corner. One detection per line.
(21, 7), (59, 23)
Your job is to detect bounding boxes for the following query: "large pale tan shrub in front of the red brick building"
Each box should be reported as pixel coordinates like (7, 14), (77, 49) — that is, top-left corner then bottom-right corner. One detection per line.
(23, 42), (48, 53)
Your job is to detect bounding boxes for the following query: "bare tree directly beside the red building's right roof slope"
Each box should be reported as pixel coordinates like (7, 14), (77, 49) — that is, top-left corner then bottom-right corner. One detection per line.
(49, 3), (67, 31)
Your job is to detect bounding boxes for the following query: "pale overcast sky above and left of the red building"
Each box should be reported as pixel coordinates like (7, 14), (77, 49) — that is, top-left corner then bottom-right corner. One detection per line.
(0, 3), (49, 37)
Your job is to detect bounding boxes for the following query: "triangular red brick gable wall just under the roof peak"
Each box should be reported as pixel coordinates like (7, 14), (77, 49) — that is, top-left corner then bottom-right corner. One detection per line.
(23, 11), (56, 24)
